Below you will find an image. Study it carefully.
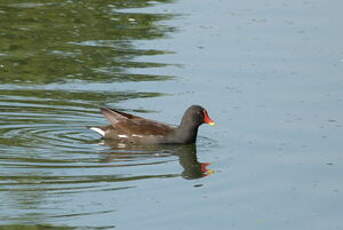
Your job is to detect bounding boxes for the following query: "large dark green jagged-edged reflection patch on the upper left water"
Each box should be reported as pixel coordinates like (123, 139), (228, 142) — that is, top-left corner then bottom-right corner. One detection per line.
(0, 1), (174, 84)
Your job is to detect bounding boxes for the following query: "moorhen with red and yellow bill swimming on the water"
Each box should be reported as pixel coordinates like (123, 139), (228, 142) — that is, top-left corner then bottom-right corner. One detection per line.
(89, 105), (215, 144)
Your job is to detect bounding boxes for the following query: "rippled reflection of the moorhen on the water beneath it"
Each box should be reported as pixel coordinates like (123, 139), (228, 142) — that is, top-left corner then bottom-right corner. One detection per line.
(101, 140), (214, 180)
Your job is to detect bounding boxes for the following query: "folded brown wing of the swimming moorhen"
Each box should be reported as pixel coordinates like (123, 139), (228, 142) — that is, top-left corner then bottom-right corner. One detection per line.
(101, 108), (174, 135)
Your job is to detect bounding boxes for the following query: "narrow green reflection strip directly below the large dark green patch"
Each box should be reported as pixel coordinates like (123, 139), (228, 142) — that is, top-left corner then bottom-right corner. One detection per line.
(0, 87), (165, 109)
